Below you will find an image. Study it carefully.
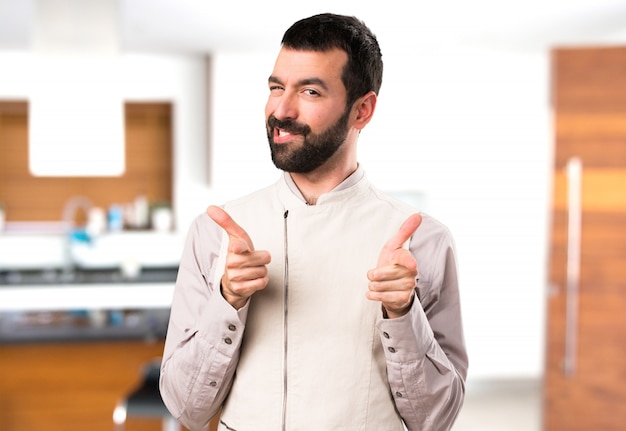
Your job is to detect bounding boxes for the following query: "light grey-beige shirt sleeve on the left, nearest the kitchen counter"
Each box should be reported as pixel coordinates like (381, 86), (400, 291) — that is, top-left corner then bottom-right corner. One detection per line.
(160, 214), (247, 430)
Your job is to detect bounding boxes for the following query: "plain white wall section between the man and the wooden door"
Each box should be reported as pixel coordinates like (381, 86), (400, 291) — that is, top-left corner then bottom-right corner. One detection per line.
(370, 48), (552, 377)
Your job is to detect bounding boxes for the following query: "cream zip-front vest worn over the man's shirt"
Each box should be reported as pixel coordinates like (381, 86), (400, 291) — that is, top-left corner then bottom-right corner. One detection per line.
(216, 178), (411, 431)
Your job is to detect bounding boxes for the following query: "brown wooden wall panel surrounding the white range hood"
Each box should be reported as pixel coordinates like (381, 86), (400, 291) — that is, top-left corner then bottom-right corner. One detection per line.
(0, 102), (172, 221)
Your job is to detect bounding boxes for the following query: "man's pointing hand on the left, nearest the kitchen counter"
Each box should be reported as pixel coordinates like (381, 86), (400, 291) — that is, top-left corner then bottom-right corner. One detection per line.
(207, 205), (271, 310)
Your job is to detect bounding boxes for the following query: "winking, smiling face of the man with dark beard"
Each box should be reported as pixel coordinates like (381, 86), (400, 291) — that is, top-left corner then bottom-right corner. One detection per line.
(265, 48), (350, 173)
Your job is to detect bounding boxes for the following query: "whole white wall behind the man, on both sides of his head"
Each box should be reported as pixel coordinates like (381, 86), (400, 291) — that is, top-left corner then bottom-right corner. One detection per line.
(0, 44), (552, 379)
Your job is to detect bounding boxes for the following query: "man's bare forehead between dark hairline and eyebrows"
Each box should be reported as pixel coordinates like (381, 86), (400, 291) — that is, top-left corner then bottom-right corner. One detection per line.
(272, 47), (348, 85)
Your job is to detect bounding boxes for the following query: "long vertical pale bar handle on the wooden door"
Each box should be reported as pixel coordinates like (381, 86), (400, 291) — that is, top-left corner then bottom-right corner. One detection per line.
(563, 157), (583, 377)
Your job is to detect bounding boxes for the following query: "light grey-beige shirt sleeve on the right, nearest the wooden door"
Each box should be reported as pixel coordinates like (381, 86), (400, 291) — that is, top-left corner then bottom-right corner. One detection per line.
(378, 218), (468, 431)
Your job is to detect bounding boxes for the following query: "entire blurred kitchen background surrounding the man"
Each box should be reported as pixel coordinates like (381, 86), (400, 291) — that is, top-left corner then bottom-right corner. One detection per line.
(0, 0), (626, 431)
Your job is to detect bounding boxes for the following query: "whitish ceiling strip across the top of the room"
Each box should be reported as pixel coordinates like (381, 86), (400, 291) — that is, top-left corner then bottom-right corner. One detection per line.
(0, 0), (626, 55)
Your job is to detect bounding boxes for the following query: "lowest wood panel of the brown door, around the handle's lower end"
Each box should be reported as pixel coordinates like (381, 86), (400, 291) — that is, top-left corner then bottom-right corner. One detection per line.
(545, 292), (626, 431)
